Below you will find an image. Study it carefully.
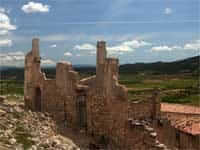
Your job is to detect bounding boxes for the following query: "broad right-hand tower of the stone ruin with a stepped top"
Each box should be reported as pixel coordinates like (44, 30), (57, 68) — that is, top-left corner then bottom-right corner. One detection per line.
(82, 41), (128, 146)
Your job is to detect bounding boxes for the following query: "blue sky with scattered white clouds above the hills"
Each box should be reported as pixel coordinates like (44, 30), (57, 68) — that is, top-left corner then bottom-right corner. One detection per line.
(0, 0), (200, 65)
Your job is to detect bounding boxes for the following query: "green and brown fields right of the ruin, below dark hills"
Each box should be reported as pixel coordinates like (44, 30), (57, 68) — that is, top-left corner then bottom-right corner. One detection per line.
(120, 74), (199, 105)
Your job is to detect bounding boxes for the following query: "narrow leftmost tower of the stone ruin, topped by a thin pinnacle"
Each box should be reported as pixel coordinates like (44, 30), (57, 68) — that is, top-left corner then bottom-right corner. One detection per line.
(24, 39), (45, 110)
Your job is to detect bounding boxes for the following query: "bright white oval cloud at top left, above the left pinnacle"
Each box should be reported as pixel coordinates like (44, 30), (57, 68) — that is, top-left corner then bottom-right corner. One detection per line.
(21, 2), (50, 13)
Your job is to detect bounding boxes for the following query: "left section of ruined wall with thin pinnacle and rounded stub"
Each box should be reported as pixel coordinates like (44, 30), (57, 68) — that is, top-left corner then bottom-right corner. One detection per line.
(24, 39), (78, 125)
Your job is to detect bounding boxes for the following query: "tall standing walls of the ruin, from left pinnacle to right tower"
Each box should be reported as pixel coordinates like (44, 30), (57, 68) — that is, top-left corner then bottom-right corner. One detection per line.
(24, 39), (167, 148)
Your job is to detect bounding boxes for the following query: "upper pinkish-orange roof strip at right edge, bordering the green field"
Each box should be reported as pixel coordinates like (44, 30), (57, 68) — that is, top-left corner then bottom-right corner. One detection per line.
(161, 103), (200, 114)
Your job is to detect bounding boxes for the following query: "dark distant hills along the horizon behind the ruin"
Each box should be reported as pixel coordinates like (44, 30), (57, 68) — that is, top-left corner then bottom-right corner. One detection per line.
(0, 56), (200, 80)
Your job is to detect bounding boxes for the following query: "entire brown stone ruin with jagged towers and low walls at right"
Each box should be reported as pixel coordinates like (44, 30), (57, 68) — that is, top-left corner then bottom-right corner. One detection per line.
(24, 39), (198, 150)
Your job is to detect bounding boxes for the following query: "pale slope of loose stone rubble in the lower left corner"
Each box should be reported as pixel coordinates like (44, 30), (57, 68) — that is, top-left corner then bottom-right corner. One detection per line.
(0, 97), (79, 150)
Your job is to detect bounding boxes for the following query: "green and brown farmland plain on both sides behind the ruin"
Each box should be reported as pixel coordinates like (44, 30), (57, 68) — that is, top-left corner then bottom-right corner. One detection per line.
(0, 72), (199, 105)
